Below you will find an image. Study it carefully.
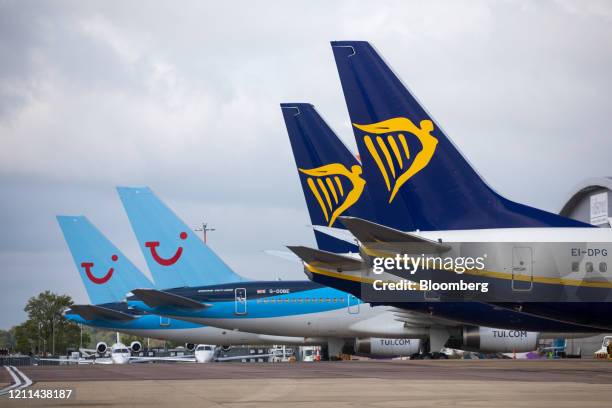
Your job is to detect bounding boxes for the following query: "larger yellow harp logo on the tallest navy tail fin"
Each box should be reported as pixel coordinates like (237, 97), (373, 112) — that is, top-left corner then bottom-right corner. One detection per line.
(353, 118), (438, 203)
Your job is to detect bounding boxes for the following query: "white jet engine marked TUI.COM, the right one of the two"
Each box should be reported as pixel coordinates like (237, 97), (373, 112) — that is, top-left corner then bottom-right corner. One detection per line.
(460, 326), (539, 353)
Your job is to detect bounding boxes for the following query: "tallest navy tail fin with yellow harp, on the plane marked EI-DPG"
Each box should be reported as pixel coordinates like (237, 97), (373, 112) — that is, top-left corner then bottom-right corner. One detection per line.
(332, 41), (589, 230)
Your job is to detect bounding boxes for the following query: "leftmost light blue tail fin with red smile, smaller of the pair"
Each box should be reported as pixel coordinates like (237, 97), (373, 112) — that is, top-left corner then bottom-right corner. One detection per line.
(57, 216), (153, 304)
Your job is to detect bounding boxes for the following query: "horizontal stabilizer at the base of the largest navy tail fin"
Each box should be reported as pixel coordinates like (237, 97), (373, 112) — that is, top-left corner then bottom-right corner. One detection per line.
(339, 217), (450, 253)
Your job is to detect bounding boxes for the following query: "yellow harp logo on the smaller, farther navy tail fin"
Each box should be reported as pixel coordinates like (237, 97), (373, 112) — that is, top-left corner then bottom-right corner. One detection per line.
(298, 163), (365, 227)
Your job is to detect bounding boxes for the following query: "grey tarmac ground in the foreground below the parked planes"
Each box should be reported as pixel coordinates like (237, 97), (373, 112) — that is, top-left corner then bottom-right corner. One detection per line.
(0, 360), (612, 408)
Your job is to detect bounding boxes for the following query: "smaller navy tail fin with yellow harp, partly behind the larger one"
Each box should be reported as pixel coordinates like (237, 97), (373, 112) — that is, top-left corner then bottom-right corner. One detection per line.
(281, 103), (373, 253)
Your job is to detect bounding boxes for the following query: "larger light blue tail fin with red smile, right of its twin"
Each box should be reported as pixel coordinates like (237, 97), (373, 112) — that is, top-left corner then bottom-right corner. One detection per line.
(117, 187), (244, 289)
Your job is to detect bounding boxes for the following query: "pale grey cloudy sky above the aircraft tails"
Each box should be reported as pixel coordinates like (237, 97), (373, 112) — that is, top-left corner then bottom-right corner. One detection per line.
(0, 0), (612, 328)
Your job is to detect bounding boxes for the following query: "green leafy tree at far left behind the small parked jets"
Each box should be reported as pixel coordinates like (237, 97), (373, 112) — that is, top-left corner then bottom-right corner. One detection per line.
(14, 291), (89, 354)
